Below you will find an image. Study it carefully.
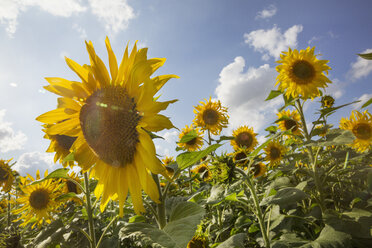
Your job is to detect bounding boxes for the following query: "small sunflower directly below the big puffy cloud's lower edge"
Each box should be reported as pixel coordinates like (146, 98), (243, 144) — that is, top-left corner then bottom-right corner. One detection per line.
(230, 126), (258, 152)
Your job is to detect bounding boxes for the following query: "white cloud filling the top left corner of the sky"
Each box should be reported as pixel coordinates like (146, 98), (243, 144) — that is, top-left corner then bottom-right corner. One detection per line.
(0, 0), (86, 37)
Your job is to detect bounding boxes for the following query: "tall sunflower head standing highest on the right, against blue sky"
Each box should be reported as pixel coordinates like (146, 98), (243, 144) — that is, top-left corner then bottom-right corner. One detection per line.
(275, 47), (331, 99)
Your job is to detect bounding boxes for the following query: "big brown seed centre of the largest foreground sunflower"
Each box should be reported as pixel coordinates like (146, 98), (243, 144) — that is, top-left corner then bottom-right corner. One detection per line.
(80, 86), (141, 166)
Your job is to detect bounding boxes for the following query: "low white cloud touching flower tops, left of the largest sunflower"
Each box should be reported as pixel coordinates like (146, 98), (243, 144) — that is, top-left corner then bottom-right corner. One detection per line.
(13, 151), (62, 177)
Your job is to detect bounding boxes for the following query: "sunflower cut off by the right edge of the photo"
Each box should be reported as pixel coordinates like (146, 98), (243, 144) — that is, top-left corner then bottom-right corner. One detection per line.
(340, 110), (372, 152)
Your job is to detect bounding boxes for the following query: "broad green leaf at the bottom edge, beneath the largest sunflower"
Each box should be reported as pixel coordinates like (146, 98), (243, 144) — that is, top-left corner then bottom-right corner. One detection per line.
(119, 202), (205, 248)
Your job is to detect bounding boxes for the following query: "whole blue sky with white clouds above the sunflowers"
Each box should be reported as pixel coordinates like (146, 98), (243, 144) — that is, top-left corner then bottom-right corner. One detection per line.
(0, 0), (372, 174)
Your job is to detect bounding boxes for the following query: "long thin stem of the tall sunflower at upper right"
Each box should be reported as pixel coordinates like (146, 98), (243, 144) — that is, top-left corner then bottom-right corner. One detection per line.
(296, 99), (325, 213)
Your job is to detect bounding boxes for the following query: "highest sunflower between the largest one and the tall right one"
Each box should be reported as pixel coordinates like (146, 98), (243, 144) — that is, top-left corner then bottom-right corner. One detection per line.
(193, 98), (229, 135)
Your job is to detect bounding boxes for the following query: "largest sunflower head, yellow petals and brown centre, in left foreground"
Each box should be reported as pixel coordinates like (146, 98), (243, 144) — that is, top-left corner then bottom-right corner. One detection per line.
(37, 38), (177, 215)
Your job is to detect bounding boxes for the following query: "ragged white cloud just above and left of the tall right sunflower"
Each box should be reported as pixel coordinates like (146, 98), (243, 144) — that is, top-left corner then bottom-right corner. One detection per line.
(244, 25), (303, 59)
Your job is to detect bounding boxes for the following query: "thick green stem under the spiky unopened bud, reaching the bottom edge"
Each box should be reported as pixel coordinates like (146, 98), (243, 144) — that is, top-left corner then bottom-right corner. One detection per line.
(235, 168), (271, 248)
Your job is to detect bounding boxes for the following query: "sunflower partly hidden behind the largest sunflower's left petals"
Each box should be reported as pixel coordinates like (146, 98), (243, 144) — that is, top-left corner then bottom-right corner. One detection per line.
(43, 125), (76, 168)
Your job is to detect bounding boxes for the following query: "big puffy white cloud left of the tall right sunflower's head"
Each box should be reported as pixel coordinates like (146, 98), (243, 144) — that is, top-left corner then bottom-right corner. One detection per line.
(215, 57), (282, 132)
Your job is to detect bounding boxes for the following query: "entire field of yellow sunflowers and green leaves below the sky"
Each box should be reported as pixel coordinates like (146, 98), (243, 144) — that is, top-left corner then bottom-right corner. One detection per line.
(0, 38), (372, 248)
